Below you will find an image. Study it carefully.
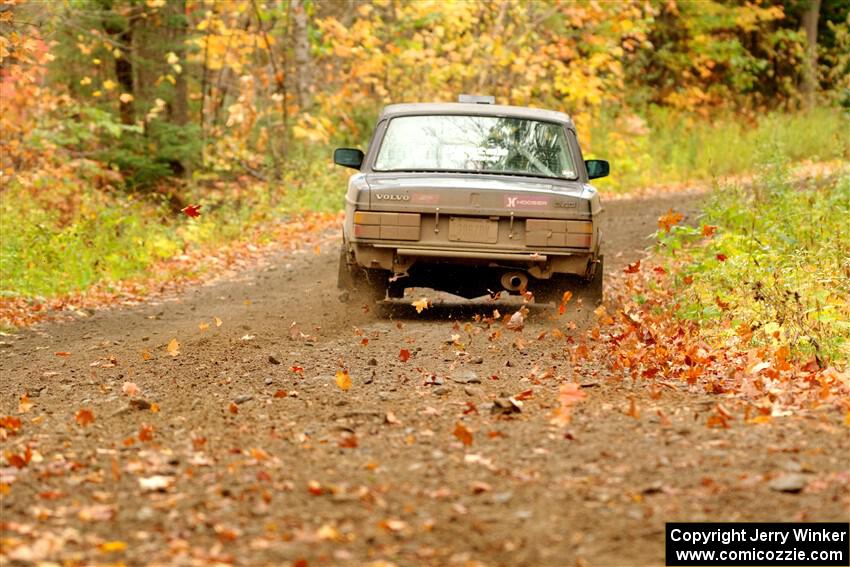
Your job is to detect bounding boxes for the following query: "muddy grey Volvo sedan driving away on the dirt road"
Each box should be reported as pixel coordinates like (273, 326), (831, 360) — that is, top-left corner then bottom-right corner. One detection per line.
(334, 97), (608, 301)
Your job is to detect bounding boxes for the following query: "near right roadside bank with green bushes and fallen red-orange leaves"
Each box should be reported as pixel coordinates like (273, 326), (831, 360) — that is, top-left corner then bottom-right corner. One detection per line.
(585, 166), (850, 427)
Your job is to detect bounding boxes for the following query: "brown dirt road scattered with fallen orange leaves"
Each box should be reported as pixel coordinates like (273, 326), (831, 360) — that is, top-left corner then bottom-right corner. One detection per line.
(0, 195), (850, 566)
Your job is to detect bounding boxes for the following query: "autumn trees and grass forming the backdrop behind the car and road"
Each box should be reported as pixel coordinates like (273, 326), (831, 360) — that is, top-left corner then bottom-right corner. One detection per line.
(0, 0), (850, 320)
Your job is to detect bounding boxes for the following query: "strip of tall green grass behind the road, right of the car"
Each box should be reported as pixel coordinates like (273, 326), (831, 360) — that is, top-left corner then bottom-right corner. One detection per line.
(578, 107), (850, 192)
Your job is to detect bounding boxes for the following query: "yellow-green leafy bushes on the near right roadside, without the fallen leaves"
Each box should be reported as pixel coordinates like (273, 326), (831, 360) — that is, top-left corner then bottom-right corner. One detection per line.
(659, 161), (850, 361)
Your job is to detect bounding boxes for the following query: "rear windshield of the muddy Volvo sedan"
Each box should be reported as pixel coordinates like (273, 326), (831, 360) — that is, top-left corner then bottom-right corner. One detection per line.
(374, 115), (578, 179)
